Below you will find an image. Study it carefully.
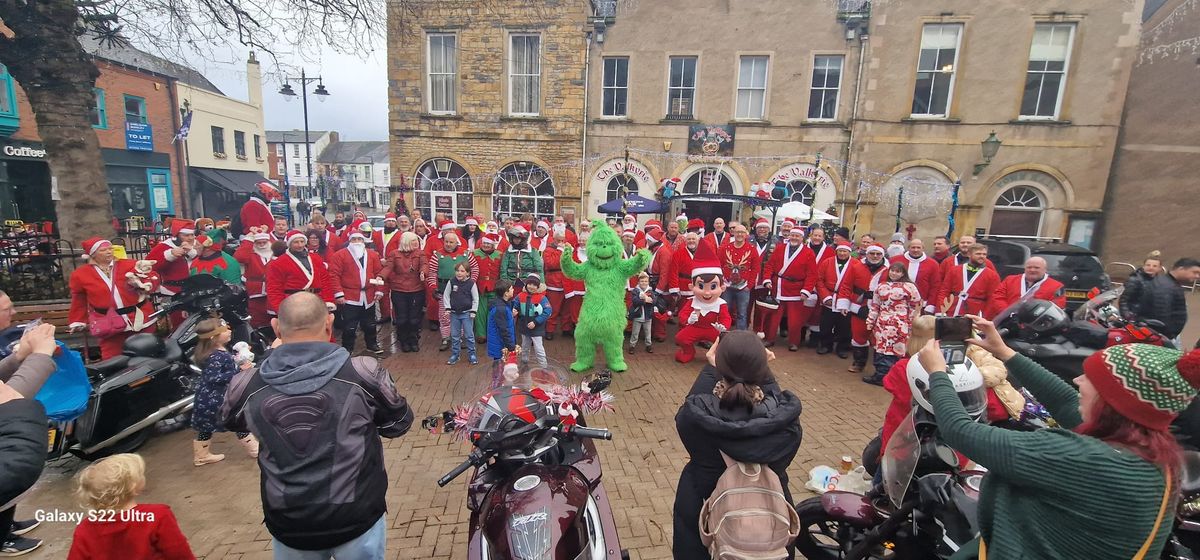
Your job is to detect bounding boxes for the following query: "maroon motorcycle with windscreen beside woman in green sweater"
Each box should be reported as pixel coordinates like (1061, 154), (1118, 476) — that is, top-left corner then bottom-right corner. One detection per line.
(796, 407), (984, 560)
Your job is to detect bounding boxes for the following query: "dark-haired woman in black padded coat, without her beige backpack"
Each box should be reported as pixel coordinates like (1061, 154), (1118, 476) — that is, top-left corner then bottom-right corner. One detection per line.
(672, 331), (802, 560)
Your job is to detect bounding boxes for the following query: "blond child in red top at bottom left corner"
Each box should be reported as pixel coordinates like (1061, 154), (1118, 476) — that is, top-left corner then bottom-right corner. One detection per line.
(67, 453), (196, 560)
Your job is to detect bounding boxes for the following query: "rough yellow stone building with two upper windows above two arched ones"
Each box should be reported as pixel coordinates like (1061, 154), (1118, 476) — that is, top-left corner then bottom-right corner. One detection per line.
(388, 0), (592, 223)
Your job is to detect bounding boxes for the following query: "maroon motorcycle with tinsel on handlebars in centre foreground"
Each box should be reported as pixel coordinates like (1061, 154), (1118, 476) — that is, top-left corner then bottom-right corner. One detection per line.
(425, 363), (628, 560)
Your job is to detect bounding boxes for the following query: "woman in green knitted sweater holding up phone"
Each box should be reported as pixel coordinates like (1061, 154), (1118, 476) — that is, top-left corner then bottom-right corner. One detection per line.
(918, 317), (1200, 560)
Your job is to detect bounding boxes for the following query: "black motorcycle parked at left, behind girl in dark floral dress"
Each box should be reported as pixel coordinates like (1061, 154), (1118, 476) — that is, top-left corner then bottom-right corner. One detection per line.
(17, 275), (266, 460)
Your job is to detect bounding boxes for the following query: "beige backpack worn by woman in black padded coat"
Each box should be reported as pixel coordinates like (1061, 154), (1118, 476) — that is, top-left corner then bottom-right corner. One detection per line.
(700, 451), (800, 560)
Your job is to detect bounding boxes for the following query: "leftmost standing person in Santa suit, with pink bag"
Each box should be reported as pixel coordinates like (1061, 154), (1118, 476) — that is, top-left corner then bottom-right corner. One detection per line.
(67, 237), (158, 360)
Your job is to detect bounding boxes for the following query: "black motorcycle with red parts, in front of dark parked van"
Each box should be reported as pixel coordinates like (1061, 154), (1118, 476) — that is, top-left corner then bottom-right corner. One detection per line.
(992, 287), (1174, 385)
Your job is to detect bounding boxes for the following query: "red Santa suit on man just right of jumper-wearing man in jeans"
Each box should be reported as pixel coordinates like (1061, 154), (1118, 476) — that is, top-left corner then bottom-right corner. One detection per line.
(760, 243), (817, 345)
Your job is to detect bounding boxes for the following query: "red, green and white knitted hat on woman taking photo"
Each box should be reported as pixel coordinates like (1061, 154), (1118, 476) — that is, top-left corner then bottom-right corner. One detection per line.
(1084, 344), (1200, 432)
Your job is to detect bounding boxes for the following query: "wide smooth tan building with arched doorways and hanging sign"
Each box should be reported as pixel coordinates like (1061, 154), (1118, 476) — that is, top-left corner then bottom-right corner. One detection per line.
(584, 0), (1139, 245)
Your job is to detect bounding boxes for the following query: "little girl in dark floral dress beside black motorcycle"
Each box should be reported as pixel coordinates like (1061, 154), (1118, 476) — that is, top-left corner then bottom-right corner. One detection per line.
(192, 319), (258, 466)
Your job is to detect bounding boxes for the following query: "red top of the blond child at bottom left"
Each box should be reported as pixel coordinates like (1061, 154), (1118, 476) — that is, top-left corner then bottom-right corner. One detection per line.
(67, 504), (196, 560)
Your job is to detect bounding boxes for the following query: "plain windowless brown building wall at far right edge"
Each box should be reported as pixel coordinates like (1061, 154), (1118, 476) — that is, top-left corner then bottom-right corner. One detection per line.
(1100, 0), (1200, 266)
